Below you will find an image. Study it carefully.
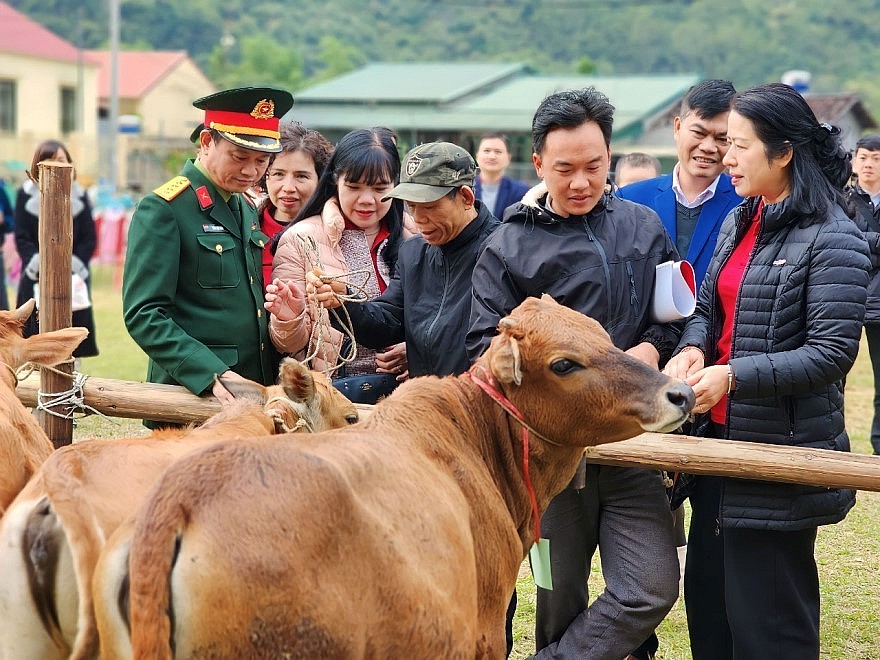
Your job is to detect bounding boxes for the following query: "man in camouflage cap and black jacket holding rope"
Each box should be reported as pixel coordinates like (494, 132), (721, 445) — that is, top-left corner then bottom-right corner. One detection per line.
(308, 142), (498, 378)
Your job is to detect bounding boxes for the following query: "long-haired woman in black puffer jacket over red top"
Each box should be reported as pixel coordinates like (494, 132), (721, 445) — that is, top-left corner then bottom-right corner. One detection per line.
(666, 83), (870, 660)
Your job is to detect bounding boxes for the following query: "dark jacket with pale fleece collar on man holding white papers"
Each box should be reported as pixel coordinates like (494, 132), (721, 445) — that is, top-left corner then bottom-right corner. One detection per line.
(467, 188), (682, 361)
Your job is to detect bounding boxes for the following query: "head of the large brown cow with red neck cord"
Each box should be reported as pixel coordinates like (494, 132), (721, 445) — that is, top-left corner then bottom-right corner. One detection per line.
(484, 295), (694, 446)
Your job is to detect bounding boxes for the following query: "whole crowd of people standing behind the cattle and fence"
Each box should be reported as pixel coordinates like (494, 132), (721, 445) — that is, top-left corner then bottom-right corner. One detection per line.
(10, 80), (880, 660)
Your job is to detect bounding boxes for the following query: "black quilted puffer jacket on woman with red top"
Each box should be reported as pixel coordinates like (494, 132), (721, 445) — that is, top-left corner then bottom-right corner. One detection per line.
(680, 198), (870, 530)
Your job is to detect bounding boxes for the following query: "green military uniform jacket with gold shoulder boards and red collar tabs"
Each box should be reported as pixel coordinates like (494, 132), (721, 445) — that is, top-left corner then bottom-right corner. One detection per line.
(122, 161), (277, 394)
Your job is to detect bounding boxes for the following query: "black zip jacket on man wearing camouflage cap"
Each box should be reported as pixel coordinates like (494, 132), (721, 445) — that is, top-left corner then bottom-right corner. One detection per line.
(338, 201), (499, 377)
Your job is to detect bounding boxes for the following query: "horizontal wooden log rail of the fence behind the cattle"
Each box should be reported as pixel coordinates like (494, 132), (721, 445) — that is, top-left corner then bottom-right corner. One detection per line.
(16, 376), (880, 491)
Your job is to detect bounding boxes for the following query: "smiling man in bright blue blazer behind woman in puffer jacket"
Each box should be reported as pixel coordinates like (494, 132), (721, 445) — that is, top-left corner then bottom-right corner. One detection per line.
(617, 80), (742, 286)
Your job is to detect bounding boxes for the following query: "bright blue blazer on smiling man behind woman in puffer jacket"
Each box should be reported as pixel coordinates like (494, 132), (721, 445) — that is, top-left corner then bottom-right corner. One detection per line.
(617, 174), (742, 287)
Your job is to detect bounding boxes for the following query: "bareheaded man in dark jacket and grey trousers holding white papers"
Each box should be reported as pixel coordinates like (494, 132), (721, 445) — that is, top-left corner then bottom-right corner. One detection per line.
(467, 88), (680, 660)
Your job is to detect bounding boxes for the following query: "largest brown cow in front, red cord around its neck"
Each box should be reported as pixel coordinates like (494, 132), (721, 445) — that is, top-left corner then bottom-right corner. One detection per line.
(113, 296), (693, 660)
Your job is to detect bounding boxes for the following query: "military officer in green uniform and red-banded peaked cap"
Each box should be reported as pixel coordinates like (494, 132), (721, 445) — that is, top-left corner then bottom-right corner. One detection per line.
(122, 87), (293, 426)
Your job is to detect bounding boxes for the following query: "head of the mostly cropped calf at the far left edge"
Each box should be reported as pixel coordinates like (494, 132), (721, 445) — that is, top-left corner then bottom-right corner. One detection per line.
(0, 298), (89, 386)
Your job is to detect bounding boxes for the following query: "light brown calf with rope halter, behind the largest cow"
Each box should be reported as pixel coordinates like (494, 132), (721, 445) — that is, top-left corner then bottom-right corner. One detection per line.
(0, 360), (358, 660)
